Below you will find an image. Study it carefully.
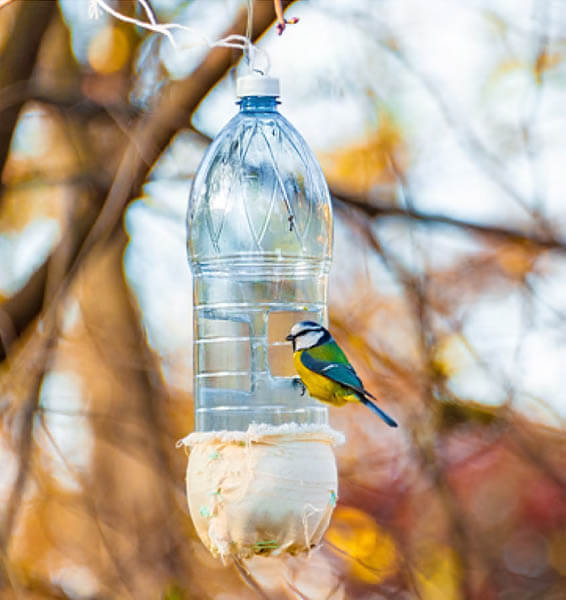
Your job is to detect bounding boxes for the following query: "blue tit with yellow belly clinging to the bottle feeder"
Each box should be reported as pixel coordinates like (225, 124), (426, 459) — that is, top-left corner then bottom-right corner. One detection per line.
(285, 321), (397, 427)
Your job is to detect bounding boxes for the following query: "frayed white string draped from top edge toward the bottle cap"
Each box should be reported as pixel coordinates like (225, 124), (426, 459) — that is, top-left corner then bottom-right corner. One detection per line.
(88, 0), (271, 74)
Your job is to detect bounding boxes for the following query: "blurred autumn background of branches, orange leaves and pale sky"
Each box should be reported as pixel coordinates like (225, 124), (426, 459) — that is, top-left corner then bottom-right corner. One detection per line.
(0, 0), (566, 600)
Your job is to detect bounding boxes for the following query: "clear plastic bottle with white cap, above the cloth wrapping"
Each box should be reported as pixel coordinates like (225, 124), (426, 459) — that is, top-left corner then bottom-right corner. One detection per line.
(187, 76), (332, 431)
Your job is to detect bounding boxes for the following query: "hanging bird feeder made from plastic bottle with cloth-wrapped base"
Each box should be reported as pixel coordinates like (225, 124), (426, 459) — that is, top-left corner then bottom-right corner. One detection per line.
(181, 75), (343, 558)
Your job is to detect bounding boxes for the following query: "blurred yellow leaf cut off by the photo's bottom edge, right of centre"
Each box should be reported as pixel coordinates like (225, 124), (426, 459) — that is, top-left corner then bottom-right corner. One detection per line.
(416, 546), (461, 600)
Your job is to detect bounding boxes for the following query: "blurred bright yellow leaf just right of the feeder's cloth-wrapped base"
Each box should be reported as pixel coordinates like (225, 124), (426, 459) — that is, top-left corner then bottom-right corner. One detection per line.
(326, 506), (398, 584)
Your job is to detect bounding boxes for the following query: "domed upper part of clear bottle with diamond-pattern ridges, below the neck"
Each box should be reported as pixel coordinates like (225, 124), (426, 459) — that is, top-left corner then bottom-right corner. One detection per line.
(187, 111), (332, 260)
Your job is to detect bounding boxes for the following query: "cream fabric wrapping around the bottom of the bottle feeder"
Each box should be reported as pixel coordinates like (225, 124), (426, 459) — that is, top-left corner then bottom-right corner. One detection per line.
(178, 423), (344, 559)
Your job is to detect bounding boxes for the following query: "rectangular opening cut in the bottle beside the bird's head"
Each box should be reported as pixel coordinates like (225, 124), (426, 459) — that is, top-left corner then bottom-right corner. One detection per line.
(267, 310), (321, 377)
